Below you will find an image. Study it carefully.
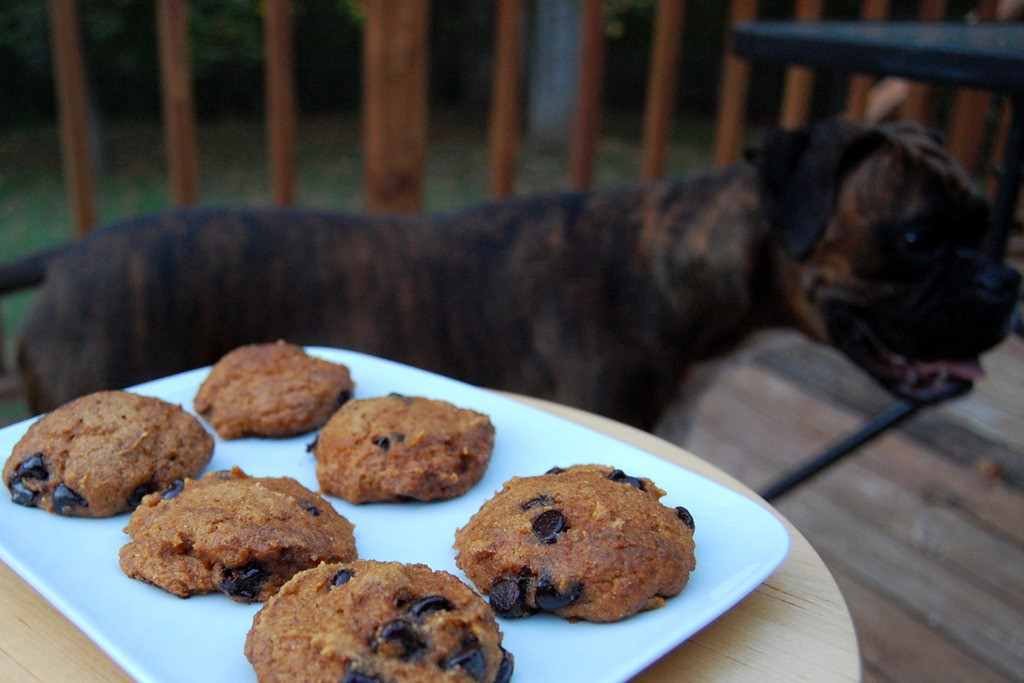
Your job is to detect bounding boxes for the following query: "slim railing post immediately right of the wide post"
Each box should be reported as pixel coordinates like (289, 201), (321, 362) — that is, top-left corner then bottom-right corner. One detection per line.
(489, 0), (524, 198)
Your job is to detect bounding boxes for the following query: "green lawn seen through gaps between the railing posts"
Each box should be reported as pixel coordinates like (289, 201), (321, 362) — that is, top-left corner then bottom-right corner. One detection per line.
(0, 111), (713, 424)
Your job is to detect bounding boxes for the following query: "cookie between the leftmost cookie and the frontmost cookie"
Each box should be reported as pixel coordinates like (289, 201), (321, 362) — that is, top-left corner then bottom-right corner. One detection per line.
(120, 468), (356, 602)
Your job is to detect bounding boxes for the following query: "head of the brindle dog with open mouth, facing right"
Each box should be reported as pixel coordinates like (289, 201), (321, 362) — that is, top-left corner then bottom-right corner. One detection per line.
(753, 121), (1020, 401)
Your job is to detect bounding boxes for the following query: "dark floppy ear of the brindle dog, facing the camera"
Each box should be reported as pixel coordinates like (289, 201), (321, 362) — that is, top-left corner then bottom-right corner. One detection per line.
(748, 120), (885, 260)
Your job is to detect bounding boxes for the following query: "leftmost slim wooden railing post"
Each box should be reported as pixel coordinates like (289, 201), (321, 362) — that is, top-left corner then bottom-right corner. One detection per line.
(49, 0), (96, 234)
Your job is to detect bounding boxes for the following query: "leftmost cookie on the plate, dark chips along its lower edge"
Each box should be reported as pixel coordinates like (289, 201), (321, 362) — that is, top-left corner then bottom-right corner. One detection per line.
(3, 391), (213, 517)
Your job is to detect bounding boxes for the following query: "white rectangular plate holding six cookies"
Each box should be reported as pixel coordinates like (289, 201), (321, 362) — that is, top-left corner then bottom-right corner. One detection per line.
(0, 347), (790, 683)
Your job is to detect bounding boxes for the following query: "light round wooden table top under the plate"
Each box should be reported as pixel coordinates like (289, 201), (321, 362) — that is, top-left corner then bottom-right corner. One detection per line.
(0, 396), (861, 683)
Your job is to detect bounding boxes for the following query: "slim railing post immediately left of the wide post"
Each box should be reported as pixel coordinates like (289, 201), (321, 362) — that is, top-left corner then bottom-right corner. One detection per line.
(263, 0), (296, 205)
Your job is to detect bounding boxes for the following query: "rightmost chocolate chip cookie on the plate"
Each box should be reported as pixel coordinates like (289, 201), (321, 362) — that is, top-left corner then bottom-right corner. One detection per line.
(455, 465), (696, 622)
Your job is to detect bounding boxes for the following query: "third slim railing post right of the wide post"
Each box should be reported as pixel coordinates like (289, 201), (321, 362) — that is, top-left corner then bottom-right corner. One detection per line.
(641, 0), (686, 180)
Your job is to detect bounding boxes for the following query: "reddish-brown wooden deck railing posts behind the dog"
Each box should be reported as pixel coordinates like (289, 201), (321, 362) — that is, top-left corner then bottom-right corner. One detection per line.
(48, 0), (1009, 233)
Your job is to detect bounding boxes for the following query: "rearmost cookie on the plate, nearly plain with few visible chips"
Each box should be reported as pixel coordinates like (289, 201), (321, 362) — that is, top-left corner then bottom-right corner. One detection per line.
(194, 341), (355, 439)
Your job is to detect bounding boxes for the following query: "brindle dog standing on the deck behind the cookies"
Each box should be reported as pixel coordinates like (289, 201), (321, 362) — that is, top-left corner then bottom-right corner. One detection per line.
(0, 120), (1020, 430)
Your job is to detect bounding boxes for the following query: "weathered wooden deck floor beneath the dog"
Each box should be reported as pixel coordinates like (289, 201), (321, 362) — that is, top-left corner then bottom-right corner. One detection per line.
(658, 327), (1024, 682)
